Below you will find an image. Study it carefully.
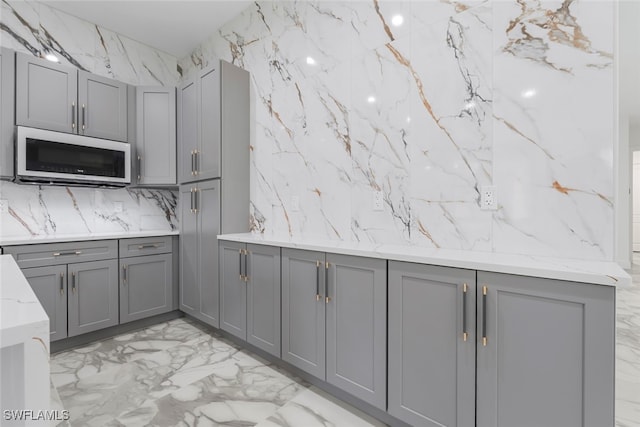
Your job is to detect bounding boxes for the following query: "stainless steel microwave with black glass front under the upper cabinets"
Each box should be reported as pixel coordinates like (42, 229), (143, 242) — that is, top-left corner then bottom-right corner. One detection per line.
(15, 126), (131, 187)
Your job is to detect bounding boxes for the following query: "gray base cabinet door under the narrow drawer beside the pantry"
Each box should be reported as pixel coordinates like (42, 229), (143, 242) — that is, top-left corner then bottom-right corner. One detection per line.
(120, 254), (173, 323)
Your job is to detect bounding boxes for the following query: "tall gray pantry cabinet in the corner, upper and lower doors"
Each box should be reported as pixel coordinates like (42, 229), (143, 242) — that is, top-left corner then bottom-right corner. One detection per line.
(177, 61), (250, 327)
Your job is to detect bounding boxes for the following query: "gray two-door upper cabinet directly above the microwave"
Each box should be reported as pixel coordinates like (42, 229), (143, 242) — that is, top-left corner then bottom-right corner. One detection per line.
(16, 52), (127, 141)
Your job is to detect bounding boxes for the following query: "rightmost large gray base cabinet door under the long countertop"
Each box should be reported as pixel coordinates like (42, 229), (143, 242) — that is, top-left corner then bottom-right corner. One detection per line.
(476, 272), (615, 427)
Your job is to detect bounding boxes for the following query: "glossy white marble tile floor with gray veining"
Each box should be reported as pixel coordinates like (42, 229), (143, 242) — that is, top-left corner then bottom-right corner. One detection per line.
(51, 260), (640, 427)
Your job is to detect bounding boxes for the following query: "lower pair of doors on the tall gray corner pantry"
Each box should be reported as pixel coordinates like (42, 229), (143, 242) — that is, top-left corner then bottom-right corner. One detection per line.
(180, 180), (220, 327)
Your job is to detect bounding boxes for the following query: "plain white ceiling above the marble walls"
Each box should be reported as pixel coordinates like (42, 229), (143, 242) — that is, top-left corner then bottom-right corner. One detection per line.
(41, 0), (252, 58)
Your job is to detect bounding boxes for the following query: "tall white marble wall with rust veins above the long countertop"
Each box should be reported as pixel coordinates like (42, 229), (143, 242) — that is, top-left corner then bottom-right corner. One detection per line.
(180, 0), (615, 260)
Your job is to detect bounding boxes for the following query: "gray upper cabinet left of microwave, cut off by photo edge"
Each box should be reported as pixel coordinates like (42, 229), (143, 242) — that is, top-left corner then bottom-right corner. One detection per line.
(0, 47), (16, 178)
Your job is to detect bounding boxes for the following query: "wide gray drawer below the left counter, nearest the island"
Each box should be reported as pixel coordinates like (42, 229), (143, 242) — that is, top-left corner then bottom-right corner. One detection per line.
(4, 240), (118, 268)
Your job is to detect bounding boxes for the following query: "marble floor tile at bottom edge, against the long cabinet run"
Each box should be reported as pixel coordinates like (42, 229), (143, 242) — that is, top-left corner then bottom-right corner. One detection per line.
(256, 387), (385, 427)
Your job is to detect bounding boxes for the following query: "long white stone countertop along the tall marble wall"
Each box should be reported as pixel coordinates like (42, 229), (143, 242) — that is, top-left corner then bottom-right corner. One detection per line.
(218, 233), (631, 288)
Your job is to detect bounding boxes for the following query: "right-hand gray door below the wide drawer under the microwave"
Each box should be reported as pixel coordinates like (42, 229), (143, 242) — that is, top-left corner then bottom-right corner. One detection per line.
(67, 259), (118, 337)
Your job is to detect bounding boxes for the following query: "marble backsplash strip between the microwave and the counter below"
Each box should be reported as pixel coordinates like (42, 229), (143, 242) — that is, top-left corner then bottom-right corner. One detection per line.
(0, 182), (178, 240)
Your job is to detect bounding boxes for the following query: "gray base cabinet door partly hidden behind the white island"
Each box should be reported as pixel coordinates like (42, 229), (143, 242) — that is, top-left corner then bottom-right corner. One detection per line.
(22, 265), (67, 341)
